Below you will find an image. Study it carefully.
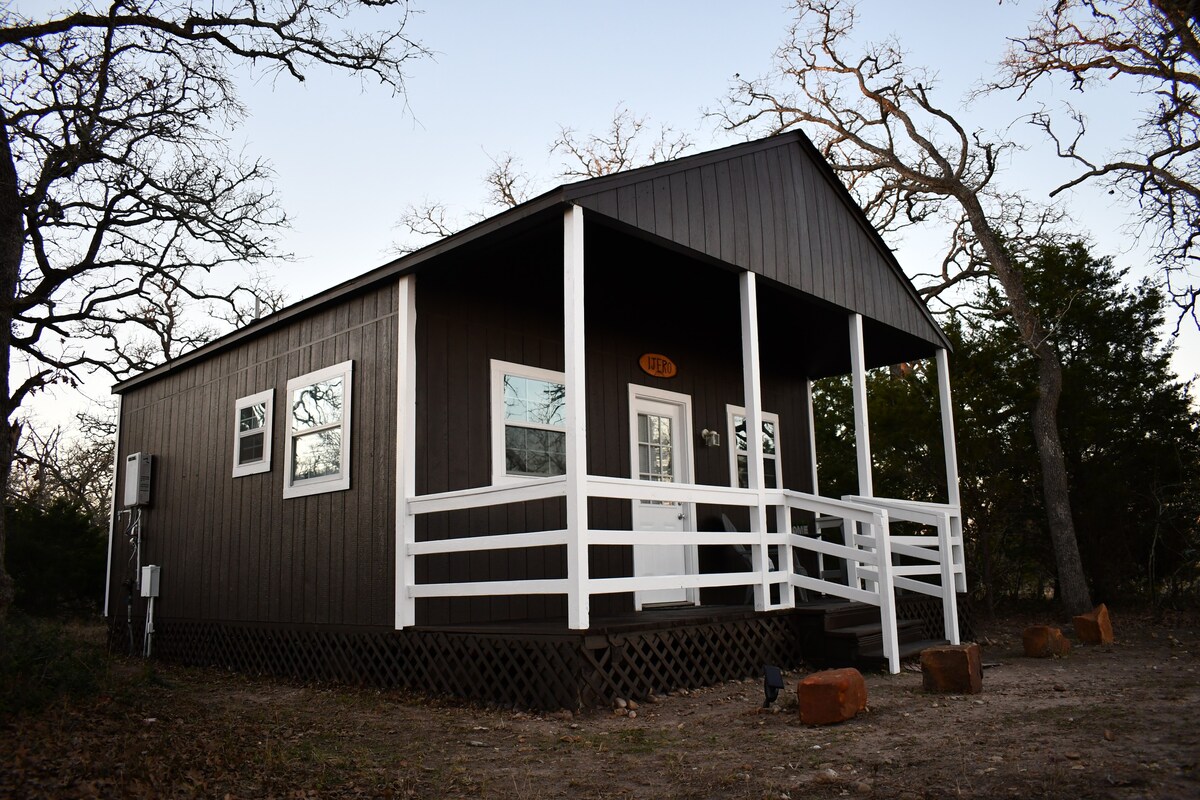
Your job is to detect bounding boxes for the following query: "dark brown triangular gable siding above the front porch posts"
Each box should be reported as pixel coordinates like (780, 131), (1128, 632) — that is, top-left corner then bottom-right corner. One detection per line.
(564, 136), (940, 345)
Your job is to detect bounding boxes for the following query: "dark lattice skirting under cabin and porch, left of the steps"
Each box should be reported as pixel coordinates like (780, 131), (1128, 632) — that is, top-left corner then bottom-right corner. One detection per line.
(109, 613), (800, 710)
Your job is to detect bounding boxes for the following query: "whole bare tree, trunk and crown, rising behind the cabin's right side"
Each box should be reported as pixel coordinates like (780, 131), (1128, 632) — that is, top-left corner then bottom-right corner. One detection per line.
(720, 0), (1091, 613)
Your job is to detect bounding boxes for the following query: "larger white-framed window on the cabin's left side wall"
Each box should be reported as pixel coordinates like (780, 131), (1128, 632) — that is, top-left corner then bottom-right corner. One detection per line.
(283, 361), (354, 498)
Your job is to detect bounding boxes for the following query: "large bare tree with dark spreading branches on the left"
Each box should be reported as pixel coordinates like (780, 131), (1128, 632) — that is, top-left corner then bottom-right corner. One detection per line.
(0, 0), (425, 616)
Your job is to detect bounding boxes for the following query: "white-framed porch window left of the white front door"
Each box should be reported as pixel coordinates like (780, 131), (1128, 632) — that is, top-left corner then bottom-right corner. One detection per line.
(492, 361), (566, 483)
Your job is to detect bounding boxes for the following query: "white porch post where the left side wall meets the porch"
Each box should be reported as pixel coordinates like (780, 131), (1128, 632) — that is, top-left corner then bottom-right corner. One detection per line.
(396, 275), (416, 630)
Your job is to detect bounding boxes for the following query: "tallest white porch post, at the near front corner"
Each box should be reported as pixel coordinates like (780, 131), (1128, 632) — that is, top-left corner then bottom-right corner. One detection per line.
(563, 205), (590, 630)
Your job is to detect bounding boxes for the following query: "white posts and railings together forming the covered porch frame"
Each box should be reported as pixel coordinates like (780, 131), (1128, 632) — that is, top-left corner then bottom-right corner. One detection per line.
(395, 204), (966, 672)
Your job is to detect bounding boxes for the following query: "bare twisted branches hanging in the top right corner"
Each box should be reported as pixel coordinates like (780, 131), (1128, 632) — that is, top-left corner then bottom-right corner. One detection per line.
(991, 0), (1200, 330)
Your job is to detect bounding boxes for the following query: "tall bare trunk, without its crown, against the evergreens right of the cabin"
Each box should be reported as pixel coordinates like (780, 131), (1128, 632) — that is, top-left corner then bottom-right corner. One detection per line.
(958, 192), (1092, 614)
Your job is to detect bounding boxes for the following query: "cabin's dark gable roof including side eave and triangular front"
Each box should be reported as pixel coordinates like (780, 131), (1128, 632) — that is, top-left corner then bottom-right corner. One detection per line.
(113, 131), (949, 393)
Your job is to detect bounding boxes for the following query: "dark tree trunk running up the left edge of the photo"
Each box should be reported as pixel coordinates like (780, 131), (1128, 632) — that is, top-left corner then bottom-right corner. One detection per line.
(0, 109), (25, 621)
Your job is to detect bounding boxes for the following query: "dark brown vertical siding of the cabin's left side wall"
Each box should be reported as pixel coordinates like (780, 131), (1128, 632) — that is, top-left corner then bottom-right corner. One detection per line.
(109, 284), (397, 627)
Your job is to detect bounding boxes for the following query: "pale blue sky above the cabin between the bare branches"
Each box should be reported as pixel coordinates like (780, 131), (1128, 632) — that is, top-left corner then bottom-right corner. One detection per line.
(18, 0), (1200, 424)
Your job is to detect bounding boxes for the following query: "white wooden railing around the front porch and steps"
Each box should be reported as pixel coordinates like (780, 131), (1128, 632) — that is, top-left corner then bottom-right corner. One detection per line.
(397, 476), (966, 673)
